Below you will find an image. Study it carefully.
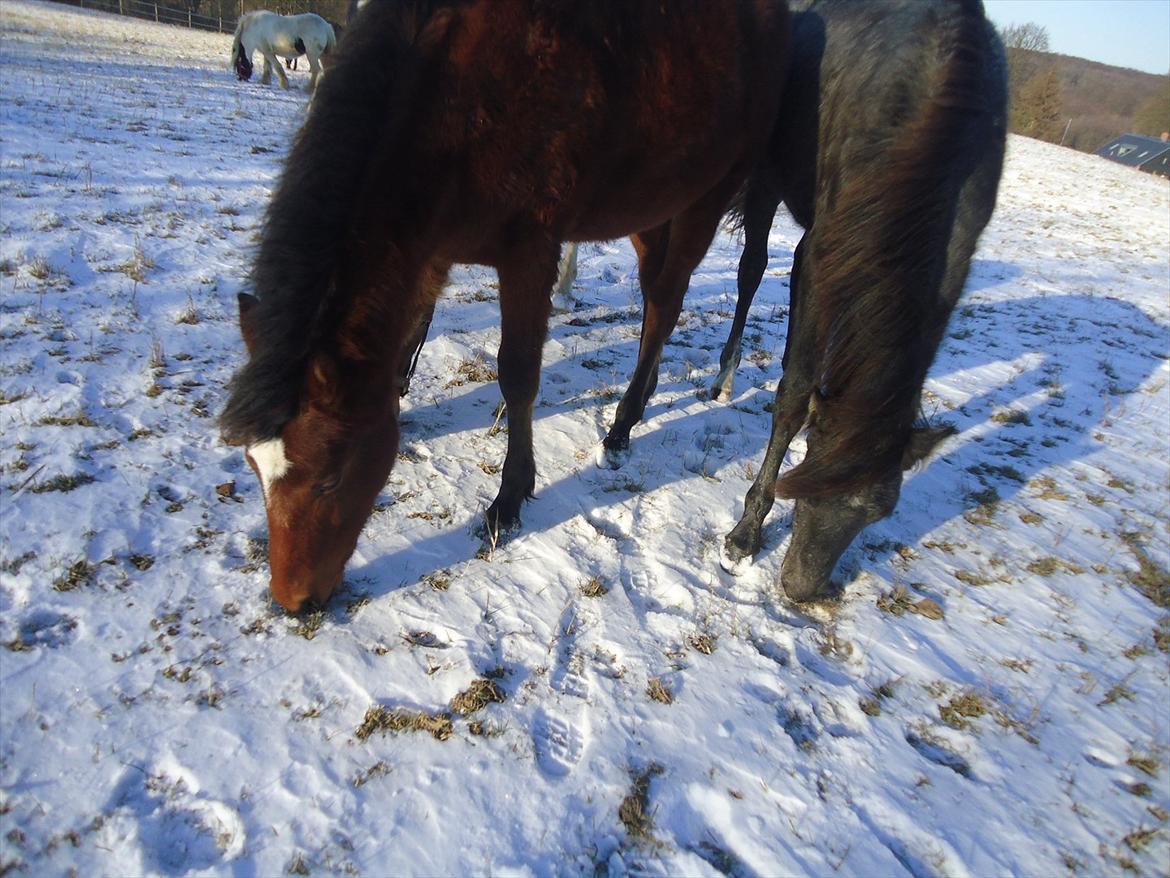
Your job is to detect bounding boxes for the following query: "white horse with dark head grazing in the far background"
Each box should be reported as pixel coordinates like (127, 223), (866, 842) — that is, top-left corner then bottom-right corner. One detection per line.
(232, 9), (337, 91)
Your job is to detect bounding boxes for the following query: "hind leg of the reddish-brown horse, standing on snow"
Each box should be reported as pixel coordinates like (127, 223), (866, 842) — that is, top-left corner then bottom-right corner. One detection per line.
(604, 187), (727, 466)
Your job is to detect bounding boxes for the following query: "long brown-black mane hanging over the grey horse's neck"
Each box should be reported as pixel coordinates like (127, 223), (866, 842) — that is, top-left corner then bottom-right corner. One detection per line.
(776, 0), (1005, 498)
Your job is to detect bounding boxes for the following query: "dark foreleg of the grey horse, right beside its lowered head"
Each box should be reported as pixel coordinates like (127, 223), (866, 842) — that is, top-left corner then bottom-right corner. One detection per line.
(723, 235), (817, 563)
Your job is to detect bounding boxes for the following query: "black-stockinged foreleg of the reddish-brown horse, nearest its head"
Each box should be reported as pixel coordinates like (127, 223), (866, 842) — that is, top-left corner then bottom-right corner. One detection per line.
(484, 242), (559, 547)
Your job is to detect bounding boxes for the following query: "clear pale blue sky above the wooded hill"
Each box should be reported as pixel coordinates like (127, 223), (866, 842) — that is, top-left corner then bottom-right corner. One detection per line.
(984, 0), (1170, 74)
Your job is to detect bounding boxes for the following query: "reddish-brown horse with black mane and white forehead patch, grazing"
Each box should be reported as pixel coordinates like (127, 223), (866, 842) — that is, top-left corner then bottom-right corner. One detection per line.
(221, 0), (789, 610)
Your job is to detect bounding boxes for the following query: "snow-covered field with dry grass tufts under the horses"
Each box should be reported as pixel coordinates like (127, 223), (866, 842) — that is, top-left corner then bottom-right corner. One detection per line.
(0, 0), (1170, 877)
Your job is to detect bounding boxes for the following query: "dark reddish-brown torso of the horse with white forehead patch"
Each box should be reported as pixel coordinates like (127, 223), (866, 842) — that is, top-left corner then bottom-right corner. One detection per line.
(388, 0), (787, 248)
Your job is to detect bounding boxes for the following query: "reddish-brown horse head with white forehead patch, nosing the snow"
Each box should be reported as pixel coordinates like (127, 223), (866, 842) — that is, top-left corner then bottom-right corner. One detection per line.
(229, 294), (398, 612)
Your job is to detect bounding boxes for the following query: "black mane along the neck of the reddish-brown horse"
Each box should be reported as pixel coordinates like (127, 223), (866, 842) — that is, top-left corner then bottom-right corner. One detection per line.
(220, 0), (452, 444)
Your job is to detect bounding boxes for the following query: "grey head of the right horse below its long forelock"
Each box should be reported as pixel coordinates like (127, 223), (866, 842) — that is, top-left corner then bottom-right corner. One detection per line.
(777, 424), (955, 601)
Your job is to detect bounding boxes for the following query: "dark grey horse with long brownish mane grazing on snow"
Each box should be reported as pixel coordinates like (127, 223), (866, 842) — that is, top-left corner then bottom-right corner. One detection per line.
(714, 0), (1006, 599)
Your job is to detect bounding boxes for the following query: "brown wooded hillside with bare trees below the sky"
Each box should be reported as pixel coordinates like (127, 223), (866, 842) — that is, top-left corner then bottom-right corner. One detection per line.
(1002, 22), (1170, 152)
